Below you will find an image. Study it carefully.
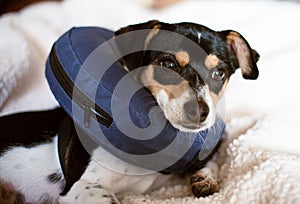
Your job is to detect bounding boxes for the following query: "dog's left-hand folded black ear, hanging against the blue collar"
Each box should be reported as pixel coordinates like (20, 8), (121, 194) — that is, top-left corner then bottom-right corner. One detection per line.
(114, 20), (160, 70)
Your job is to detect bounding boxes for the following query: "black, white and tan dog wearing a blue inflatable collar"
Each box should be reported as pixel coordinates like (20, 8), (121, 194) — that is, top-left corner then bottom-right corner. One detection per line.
(0, 20), (259, 204)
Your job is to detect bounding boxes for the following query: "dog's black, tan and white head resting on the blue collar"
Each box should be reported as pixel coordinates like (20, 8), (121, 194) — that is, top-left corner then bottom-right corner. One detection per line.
(115, 21), (259, 132)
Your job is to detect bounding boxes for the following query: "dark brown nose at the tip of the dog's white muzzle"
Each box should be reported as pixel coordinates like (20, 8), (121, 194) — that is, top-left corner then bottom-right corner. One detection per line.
(184, 100), (209, 123)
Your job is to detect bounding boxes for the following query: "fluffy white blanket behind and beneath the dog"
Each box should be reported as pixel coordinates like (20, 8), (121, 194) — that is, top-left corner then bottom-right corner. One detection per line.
(0, 0), (300, 204)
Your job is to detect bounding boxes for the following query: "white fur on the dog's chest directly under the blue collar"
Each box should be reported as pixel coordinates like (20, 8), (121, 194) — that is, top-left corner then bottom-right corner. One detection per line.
(60, 146), (160, 203)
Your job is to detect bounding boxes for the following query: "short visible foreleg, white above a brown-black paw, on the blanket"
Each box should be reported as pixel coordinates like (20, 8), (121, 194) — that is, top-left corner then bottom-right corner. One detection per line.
(191, 161), (219, 197)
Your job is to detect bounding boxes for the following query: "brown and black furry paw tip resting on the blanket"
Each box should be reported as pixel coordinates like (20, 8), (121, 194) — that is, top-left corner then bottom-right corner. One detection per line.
(191, 171), (219, 197)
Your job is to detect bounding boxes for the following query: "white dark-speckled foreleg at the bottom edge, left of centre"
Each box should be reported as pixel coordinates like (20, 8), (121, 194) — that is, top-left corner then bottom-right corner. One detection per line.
(59, 179), (120, 204)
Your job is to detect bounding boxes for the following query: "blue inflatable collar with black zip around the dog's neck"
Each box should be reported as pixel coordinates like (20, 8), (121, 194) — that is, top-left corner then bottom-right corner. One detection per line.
(46, 27), (225, 173)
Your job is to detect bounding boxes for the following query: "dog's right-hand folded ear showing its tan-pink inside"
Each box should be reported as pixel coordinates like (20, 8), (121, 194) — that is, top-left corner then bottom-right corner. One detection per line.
(223, 30), (259, 79)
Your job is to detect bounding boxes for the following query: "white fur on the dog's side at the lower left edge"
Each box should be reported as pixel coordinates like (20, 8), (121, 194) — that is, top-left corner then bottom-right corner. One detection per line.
(0, 138), (63, 203)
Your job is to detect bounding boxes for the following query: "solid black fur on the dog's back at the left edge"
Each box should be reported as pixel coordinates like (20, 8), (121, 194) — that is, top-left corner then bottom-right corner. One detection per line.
(0, 108), (66, 155)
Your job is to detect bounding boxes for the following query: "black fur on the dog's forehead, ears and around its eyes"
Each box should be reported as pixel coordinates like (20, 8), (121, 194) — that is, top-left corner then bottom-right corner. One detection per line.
(115, 21), (259, 95)
